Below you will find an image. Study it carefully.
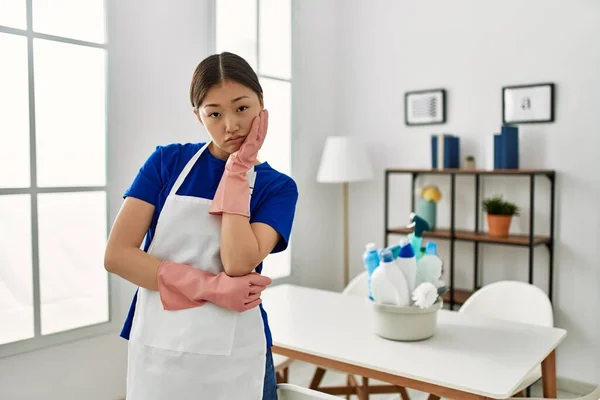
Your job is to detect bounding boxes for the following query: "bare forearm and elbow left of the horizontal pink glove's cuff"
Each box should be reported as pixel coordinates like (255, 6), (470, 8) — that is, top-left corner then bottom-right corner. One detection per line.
(104, 247), (162, 290)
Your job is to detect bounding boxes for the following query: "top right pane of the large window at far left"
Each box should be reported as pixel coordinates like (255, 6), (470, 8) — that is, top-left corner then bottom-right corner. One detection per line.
(32, 0), (106, 43)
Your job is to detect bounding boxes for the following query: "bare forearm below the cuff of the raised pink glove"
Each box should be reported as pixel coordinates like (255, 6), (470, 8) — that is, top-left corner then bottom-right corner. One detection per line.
(221, 213), (262, 276)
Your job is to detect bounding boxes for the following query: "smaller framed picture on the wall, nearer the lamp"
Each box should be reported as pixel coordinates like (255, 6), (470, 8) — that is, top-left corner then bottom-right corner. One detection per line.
(404, 89), (446, 126)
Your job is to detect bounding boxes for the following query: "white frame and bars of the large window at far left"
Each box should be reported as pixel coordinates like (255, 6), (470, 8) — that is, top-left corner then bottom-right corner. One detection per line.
(0, 0), (122, 359)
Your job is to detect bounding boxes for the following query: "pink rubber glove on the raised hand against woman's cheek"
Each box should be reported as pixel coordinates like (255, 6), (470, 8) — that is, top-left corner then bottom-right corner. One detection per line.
(208, 110), (269, 217)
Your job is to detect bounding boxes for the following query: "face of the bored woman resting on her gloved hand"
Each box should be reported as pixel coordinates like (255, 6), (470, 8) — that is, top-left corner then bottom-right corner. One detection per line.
(194, 81), (263, 159)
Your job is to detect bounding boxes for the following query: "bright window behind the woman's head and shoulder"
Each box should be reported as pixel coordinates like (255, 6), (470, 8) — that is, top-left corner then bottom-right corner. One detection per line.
(215, 0), (292, 278)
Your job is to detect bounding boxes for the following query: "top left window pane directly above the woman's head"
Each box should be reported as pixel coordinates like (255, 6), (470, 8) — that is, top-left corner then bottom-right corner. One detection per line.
(216, 0), (257, 71)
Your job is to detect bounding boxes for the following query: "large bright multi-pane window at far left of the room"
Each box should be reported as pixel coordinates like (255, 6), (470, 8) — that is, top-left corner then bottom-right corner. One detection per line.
(0, 0), (110, 355)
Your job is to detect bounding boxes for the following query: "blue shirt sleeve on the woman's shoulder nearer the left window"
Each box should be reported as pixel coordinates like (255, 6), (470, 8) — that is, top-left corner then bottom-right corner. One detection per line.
(123, 146), (165, 206)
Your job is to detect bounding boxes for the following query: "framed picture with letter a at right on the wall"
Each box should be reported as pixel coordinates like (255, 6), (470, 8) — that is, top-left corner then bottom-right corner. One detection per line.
(502, 83), (554, 124)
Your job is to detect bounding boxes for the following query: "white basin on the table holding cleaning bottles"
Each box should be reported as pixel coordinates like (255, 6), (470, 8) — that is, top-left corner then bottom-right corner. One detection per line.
(373, 299), (443, 342)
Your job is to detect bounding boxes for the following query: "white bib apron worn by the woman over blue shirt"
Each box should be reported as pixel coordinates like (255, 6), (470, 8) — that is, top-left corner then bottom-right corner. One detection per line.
(127, 144), (267, 400)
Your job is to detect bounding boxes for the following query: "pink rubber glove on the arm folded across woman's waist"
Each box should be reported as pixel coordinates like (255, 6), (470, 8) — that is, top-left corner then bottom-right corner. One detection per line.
(157, 261), (272, 312)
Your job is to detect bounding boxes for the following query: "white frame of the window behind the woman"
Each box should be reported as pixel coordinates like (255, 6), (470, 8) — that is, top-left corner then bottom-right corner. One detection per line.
(206, 0), (298, 285)
